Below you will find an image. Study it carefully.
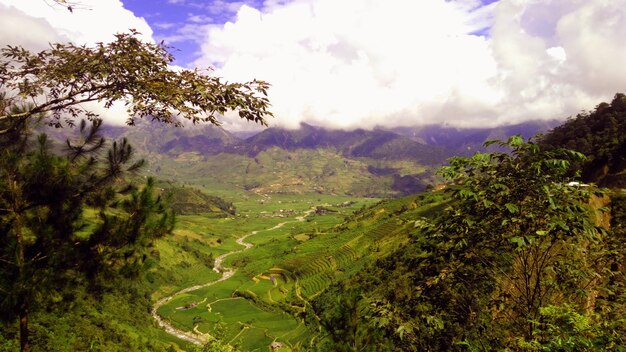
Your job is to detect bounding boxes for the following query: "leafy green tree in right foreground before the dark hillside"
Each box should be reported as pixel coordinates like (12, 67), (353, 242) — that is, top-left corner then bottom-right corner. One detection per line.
(426, 136), (604, 346)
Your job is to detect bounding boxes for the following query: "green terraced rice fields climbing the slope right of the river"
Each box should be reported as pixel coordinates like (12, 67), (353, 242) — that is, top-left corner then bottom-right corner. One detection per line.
(153, 192), (444, 351)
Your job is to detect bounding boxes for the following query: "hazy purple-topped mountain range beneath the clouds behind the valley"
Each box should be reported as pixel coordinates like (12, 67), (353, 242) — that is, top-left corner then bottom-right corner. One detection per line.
(85, 120), (556, 197)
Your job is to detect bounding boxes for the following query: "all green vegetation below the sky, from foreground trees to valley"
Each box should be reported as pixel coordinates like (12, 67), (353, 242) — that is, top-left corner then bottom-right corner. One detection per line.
(0, 22), (626, 351)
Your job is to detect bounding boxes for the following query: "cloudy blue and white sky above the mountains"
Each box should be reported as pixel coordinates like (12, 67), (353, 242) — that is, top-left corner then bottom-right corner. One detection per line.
(0, 0), (626, 130)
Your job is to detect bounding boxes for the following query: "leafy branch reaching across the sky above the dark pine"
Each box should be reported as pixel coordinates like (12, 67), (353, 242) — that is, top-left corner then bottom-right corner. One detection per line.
(0, 31), (271, 133)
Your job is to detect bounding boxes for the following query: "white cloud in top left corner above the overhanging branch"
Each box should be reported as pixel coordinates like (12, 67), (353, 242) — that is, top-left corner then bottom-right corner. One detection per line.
(0, 0), (152, 123)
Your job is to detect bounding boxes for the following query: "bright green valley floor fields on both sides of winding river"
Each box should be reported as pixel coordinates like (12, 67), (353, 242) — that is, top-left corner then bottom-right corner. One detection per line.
(149, 194), (377, 351)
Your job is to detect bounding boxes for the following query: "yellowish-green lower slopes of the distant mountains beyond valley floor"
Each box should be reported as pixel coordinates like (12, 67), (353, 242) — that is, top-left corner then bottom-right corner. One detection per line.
(141, 147), (435, 199)
